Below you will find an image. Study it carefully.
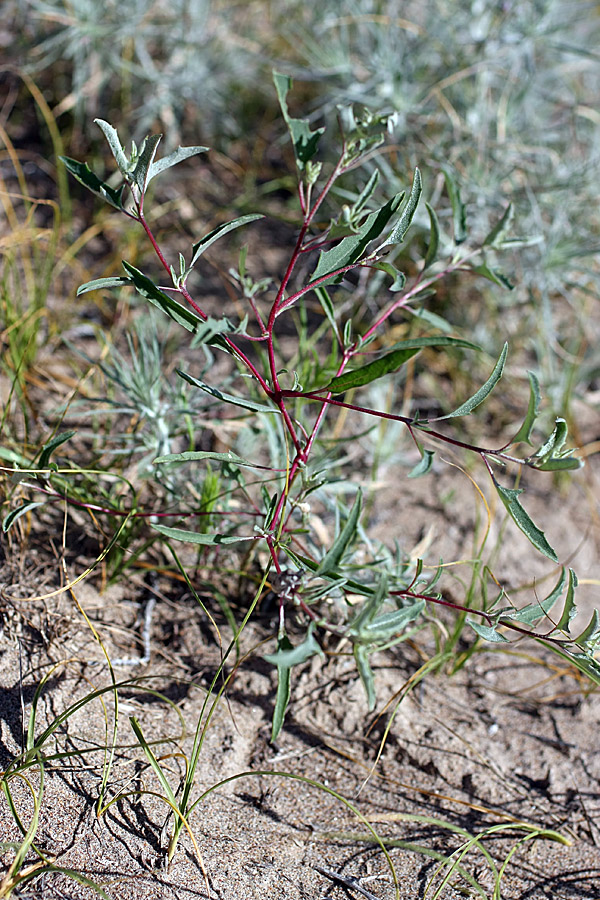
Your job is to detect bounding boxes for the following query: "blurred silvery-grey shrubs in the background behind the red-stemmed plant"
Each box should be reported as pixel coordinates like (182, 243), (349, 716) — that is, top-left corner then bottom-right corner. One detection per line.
(0, 0), (600, 392)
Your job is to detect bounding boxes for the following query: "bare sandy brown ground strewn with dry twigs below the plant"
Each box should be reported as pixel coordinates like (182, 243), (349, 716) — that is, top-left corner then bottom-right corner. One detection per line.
(0, 440), (600, 900)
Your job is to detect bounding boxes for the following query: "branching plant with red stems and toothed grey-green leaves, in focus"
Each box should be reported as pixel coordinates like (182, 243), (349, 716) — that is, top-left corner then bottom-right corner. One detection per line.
(35, 73), (600, 716)
